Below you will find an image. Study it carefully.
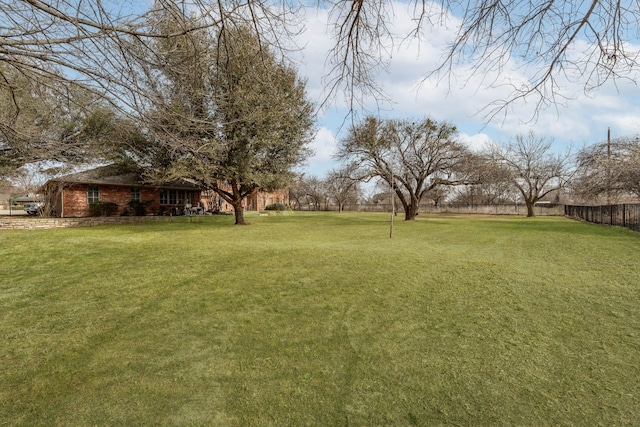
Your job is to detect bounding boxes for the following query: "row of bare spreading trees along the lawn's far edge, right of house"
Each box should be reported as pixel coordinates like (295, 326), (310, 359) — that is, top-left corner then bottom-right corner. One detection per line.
(291, 117), (640, 220)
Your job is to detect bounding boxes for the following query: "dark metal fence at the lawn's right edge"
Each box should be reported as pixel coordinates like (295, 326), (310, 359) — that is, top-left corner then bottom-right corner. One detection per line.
(564, 204), (640, 231)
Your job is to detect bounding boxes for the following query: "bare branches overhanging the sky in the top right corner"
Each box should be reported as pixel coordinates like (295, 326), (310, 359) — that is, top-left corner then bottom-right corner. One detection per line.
(430, 0), (640, 120)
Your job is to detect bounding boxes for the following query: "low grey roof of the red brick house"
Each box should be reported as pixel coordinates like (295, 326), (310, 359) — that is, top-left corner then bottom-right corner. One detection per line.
(50, 164), (200, 190)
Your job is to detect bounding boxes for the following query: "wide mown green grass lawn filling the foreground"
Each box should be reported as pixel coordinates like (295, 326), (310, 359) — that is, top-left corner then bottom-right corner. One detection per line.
(0, 213), (640, 426)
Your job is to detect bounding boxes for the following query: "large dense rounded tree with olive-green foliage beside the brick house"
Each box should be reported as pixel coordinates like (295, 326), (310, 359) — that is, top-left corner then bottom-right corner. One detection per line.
(115, 10), (314, 224)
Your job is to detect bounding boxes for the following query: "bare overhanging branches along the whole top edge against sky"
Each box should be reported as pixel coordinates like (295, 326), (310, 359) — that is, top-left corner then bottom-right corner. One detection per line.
(5, 0), (640, 128)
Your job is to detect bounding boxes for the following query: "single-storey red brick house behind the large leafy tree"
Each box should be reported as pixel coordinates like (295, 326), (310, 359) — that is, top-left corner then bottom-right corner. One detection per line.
(43, 165), (202, 218)
